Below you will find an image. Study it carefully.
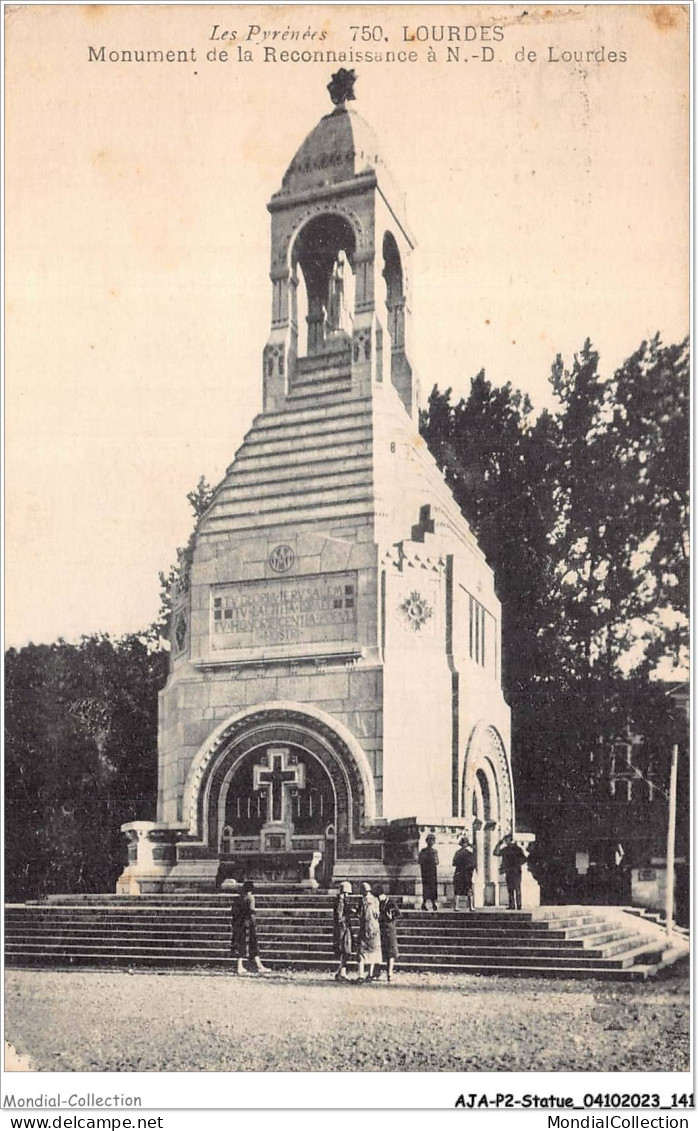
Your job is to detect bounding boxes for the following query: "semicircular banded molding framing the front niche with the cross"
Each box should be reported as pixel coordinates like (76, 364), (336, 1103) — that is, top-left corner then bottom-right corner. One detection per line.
(184, 700), (376, 847)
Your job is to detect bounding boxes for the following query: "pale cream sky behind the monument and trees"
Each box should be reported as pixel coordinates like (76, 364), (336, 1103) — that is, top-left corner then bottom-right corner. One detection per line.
(6, 5), (689, 647)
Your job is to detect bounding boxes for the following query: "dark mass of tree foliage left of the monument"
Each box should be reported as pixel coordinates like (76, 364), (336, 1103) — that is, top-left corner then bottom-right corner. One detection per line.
(5, 636), (167, 900)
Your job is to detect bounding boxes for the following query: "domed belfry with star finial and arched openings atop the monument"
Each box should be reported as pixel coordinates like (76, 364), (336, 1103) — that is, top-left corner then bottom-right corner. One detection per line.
(264, 68), (416, 416)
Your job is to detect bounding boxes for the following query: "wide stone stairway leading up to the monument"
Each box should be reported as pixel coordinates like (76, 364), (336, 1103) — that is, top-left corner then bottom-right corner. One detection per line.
(5, 891), (688, 978)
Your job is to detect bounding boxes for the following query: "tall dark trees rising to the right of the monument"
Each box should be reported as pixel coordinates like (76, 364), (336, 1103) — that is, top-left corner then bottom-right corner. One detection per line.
(421, 337), (689, 820)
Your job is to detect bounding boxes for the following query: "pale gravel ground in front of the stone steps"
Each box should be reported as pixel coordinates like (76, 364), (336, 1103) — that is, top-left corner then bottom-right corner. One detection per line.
(5, 962), (690, 1072)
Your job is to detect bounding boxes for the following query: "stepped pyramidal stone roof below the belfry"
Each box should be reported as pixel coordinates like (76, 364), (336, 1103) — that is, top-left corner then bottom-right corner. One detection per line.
(193, 387), (480, 563)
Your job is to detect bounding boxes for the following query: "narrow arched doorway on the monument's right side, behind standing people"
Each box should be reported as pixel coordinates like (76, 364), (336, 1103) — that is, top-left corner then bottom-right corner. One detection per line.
(462, 725), (514, 907)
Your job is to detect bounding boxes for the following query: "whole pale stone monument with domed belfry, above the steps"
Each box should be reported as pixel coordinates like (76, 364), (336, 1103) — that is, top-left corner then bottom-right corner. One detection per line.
(119, 70), (533, 905)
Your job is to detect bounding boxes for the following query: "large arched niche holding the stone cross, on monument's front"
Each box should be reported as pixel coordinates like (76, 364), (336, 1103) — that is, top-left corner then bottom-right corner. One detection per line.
(184, 702), (376, 884)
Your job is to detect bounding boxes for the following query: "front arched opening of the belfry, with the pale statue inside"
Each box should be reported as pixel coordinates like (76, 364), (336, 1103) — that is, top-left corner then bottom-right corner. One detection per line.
(293, 213), (356, 356)
